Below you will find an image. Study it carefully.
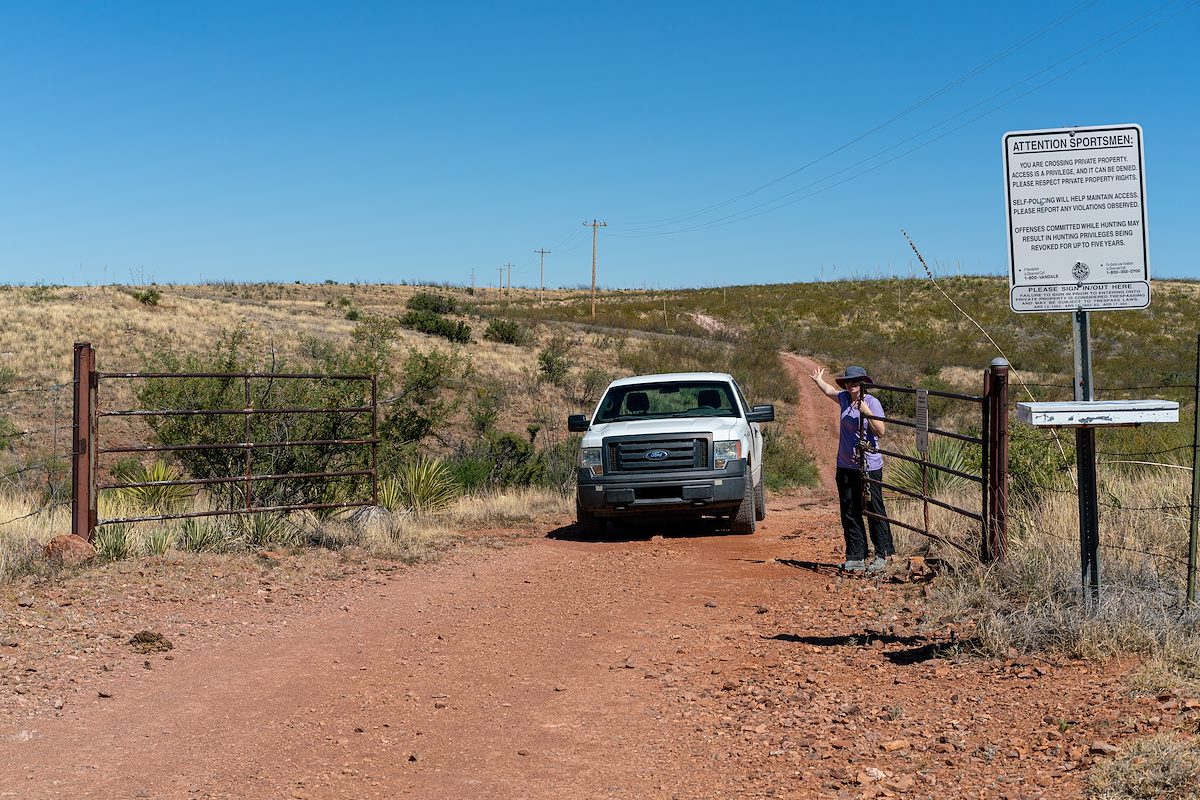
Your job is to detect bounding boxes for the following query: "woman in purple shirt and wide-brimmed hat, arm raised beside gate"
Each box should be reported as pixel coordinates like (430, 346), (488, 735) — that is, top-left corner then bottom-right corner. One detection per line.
(812, 367), (895, 572)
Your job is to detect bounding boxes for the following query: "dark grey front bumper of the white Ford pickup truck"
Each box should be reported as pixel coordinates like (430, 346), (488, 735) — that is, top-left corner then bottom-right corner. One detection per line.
(576, 459), (746, 517)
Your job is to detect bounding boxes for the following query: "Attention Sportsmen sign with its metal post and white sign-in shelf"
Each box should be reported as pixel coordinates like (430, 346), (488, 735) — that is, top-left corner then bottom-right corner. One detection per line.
(1003, 125), (1161, 608)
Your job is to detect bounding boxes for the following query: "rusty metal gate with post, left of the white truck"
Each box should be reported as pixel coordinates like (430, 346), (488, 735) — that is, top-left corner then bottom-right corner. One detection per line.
(71, 343), (379, 541)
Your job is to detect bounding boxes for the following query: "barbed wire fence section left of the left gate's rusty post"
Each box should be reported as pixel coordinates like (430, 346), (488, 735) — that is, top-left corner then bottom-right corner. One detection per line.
(0, 381), (73, 530)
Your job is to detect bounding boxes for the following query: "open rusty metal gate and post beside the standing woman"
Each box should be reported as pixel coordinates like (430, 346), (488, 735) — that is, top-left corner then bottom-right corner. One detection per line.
(863, 359), (1009, 563)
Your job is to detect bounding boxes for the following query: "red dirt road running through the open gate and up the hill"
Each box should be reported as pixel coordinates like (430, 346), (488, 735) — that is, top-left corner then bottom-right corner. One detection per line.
(0, 359), (1188, 800)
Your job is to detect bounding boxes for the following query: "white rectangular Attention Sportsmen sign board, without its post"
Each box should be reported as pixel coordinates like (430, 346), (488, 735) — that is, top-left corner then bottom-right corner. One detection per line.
(1004, 125), (1150, 312)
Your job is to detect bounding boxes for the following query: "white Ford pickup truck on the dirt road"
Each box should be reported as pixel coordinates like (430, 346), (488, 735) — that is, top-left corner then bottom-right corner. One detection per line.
(566, 372), (775, 534)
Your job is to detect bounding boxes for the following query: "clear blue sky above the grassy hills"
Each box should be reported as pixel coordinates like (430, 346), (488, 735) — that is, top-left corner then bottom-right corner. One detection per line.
(0, 0), (1200, 288)
